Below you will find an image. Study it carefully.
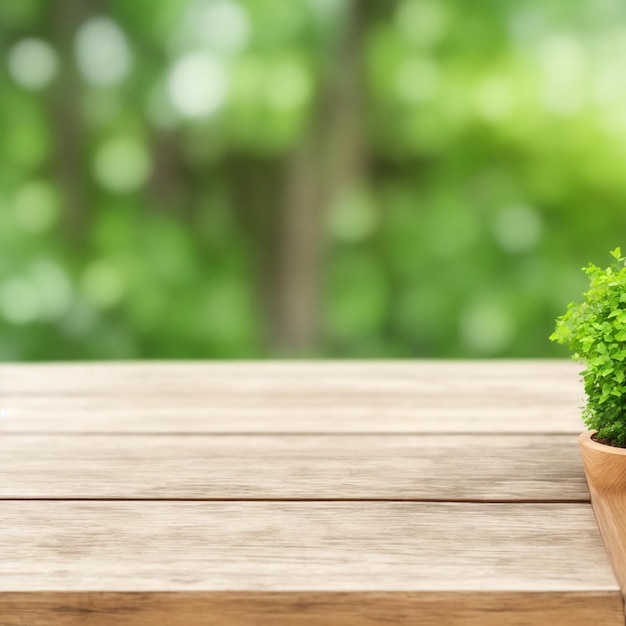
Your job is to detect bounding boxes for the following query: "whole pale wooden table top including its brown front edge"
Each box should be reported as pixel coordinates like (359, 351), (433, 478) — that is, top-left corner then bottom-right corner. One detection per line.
(0, 361), (624, 626)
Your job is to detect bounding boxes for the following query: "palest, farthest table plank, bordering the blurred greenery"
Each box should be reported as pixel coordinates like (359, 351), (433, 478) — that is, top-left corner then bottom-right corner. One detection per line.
(0, 361), (583, 434)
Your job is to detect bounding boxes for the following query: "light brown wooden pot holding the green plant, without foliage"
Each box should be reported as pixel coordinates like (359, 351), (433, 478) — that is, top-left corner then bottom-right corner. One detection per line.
(578, 430), (626, 593)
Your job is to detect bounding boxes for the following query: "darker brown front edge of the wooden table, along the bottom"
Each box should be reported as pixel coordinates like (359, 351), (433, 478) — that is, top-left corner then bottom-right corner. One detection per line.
(0, 591), (624, 626)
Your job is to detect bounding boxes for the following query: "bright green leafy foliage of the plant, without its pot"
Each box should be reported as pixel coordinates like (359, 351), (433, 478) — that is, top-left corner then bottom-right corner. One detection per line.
(550, 248), (626, 448)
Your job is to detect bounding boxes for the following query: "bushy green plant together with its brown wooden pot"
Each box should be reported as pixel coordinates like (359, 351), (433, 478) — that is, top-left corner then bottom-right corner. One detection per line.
(550, 248), (626, 591)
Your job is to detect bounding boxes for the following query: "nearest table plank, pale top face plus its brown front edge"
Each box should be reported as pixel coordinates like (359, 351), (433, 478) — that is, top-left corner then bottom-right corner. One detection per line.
(0, 502), (623, 626)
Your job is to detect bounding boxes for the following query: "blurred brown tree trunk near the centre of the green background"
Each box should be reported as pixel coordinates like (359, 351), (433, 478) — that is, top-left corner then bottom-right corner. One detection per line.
(271, 0), (366, 356)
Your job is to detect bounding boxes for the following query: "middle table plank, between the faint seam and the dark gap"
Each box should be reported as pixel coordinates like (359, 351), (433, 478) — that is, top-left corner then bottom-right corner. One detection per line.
(0, 435), (589, 501)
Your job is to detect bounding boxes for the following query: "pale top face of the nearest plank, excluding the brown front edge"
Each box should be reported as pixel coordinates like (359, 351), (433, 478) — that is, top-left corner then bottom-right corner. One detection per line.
(0, 501), (619, 588)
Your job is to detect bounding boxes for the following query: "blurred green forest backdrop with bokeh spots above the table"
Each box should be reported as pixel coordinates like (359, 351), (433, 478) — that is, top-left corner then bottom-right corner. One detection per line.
(0, 0), (626, 360)
